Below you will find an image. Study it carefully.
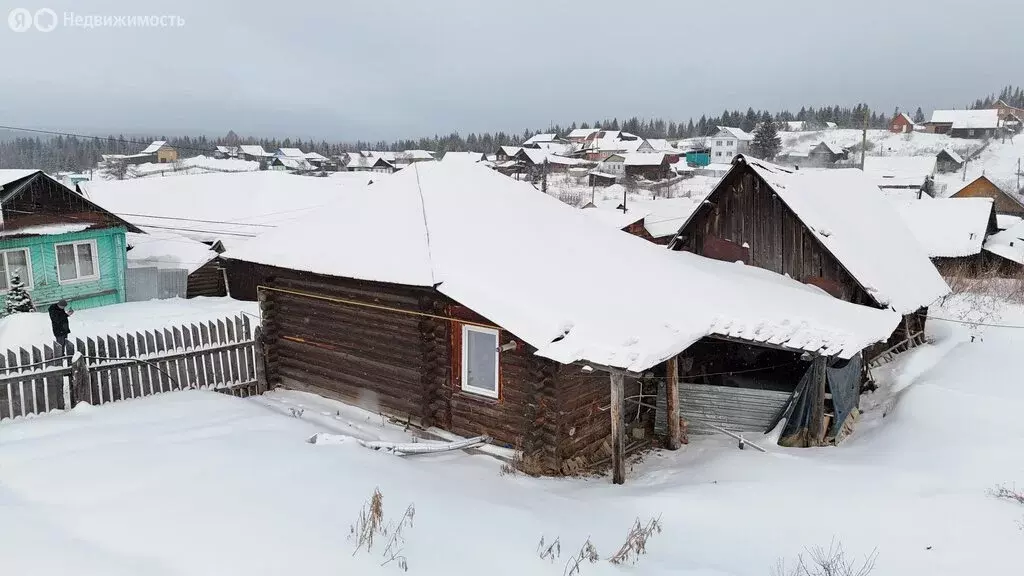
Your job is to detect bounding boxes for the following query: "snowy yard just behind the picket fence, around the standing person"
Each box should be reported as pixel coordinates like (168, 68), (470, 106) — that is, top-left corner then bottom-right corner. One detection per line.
(0, 297), (259, 351)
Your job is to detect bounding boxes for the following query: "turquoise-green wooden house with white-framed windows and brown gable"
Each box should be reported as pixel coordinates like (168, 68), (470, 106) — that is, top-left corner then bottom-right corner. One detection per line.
(0, 170), (141, 310)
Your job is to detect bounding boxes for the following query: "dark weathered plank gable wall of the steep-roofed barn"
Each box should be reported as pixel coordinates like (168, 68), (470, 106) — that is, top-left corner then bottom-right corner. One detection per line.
(677, 167), (877, 305)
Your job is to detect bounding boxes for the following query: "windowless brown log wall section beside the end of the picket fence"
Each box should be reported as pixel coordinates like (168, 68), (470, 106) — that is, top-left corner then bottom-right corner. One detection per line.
(261, 271), (433, 424)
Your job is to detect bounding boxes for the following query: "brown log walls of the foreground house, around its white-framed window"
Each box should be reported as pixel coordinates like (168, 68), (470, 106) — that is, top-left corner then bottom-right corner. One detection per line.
(241, 262), (640, 474)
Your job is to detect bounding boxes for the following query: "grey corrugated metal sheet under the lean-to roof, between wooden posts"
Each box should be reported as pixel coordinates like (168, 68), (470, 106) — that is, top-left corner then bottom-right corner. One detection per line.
(654, 382), (793, 435)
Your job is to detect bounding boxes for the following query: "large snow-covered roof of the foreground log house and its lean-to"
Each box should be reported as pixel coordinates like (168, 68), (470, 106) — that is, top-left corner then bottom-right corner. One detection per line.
(227, 162), (899, 371)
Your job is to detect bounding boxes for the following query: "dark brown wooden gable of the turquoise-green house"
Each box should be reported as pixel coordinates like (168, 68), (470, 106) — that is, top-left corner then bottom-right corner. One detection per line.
(0, 172), (142, 233)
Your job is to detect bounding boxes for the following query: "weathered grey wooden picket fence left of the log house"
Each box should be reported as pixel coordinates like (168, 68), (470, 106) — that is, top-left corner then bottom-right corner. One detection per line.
(0, 315), (266, 419)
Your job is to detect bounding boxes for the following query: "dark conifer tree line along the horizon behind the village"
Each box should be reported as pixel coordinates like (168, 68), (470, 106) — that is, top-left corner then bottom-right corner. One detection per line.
(0, 86), (1024, 172)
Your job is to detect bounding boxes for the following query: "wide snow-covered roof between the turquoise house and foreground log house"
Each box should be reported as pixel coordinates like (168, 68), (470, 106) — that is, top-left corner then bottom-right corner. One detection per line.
(79, 170), (347, 245)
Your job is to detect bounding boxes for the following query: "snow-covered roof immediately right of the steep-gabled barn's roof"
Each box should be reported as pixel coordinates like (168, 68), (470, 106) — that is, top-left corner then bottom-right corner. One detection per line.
(894, 198), (993, 258)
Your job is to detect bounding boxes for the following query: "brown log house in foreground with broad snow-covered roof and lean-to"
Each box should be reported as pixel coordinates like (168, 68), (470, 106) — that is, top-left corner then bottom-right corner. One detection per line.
(225, 162), (899, 480)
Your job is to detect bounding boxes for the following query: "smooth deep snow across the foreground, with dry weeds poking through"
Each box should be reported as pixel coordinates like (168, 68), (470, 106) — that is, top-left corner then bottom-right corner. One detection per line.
(0, 295), (1024, 576)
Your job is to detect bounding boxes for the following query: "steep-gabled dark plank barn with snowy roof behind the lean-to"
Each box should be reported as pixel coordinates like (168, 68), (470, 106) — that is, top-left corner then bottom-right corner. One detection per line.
(670, 156), (949, 354)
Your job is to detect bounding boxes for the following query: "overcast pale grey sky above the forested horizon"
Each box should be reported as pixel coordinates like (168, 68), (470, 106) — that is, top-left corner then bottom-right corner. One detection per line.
(0, 0), (1024, 140)
